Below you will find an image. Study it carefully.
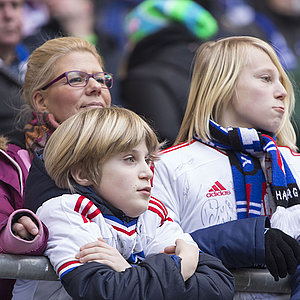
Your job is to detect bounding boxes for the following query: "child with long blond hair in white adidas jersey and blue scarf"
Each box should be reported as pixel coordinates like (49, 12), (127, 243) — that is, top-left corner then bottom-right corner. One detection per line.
(152, 36), (300, 299)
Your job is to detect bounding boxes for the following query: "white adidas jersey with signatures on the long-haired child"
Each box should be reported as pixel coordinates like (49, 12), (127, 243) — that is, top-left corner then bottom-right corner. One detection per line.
(152, 140), (300, 232)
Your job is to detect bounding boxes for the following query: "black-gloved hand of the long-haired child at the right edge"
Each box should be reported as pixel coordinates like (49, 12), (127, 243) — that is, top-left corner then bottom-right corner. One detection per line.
(265, 228), (300, 281)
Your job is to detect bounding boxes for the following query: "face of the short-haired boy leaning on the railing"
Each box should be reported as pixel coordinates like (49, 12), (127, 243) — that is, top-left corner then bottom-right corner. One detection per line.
(93, 141), (153, 217)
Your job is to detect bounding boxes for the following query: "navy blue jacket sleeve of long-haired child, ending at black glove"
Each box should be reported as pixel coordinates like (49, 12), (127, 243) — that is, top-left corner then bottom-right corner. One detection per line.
(191, 216), (270, 269)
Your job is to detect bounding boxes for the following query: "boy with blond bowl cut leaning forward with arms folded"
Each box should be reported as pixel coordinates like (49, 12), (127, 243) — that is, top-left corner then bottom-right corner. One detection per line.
(14, 108), (233, 300)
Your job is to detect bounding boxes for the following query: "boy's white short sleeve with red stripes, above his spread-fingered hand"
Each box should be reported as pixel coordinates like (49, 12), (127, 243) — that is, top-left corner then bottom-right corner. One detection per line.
(37, 195), (103, 277)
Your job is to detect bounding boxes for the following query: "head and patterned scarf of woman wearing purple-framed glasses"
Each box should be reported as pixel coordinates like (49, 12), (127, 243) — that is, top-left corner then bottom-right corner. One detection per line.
(24, 37), (113, 152)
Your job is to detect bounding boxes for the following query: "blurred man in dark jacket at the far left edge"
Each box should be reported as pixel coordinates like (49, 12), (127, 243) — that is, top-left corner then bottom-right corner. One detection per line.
(0, 0), (29, 147)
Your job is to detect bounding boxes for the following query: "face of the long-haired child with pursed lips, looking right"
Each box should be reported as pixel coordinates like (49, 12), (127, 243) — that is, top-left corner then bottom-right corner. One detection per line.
(220, 47), (287, 132)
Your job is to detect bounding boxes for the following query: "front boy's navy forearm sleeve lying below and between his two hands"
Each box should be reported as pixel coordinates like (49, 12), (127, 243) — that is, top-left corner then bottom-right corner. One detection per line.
(61, 253), (185, 300)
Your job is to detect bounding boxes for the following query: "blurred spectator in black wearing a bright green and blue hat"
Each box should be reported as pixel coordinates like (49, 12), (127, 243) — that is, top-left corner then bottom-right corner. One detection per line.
(120, 0), (217, 145)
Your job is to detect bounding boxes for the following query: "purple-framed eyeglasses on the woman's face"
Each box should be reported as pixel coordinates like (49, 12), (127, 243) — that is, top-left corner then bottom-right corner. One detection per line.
(42, 71), (113, 90)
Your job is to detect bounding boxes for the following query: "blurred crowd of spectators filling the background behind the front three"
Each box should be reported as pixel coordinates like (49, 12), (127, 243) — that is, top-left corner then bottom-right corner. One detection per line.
(0, 0), (300, 146)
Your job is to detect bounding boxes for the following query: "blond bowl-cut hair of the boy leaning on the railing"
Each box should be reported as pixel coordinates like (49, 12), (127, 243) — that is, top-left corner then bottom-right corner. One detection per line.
(43, 107), (160, 191)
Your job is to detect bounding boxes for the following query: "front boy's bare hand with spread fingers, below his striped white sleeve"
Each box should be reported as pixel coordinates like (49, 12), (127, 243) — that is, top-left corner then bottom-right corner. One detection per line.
(75, 238), (131, 272)
